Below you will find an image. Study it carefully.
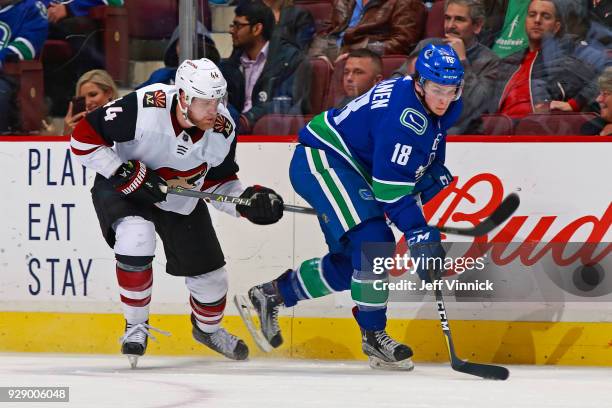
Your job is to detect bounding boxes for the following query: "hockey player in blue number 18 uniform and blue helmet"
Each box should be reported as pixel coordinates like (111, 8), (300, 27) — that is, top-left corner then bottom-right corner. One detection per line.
(236, 45), (463, 370)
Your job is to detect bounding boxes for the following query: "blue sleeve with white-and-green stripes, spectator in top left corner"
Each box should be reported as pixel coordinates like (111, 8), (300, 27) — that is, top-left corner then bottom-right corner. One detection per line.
(0, 2), (49, 63)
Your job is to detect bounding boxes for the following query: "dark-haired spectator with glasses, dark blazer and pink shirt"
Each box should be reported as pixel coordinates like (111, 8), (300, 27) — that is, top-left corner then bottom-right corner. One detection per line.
(220, 1), (308, 133)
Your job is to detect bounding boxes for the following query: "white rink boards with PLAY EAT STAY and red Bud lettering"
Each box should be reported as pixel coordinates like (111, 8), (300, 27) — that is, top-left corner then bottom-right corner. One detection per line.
(0, 138), (612, 318)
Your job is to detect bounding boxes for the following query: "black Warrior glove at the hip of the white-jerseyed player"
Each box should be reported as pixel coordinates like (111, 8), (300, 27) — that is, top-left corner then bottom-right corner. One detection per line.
(109, 160), (167, 204)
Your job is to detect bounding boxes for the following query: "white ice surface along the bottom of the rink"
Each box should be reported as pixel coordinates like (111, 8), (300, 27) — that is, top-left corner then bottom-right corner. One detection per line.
(0, 354), (612, 408)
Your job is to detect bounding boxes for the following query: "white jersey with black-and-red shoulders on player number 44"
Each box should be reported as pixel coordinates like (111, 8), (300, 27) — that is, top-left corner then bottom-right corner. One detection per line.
(70, 84), (235, 214)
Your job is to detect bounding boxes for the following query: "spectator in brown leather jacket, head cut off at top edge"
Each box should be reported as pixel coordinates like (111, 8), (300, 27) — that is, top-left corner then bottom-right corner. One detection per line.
(309, 0), (427, 64)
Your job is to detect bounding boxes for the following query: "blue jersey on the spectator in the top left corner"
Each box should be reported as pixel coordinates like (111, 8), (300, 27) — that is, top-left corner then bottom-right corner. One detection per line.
(0, 0), (49, 64)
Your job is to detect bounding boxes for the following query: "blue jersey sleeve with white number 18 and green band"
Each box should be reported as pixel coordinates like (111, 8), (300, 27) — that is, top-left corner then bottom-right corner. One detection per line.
(372, 128), (429, 233)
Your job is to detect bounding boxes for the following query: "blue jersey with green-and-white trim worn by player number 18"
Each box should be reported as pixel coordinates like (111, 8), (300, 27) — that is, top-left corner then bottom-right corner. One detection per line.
(299, 77), (462, 232)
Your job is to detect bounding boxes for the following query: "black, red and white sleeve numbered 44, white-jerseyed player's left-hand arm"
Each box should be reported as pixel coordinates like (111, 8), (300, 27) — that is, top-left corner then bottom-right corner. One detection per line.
(70, 92), (138, 178)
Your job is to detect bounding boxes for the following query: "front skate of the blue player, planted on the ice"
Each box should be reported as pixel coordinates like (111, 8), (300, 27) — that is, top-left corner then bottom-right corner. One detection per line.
(361, 329), (414, 371)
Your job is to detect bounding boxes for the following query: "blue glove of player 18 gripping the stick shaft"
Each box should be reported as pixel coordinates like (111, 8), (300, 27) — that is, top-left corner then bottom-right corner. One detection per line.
(406, 227), (446, 282)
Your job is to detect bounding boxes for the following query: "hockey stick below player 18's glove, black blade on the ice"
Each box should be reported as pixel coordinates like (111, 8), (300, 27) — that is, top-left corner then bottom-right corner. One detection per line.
(429, 278), (510, 380)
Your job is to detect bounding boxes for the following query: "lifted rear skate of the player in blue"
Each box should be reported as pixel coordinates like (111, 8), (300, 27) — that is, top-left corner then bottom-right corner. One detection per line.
(234, 281), (283, 352)
